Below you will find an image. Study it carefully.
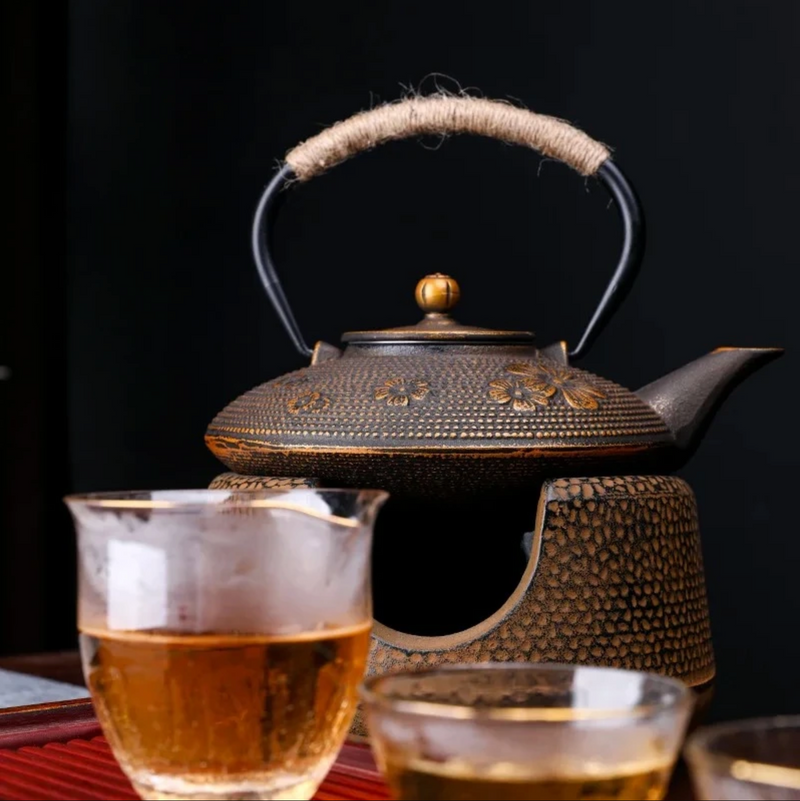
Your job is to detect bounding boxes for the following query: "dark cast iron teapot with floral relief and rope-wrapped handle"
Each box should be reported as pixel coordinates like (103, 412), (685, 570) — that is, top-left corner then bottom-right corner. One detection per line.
(206, 97), (782, 497)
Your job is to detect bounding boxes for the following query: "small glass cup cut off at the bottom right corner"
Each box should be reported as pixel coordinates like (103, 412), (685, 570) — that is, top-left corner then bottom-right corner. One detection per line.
(686, 717), (800, 801)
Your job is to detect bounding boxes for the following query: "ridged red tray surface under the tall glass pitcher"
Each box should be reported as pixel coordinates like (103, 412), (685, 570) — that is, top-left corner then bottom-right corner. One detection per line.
(0, 701), (390, 801)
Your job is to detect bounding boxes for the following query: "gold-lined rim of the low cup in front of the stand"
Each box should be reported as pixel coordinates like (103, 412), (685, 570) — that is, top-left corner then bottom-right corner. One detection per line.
(360, 662), (692, 723)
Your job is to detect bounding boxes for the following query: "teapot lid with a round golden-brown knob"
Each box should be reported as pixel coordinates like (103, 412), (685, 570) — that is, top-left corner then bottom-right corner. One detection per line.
(342, 273), (534, 345)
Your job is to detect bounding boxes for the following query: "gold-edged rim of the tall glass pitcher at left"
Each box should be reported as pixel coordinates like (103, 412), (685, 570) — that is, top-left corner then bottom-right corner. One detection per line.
(64, 487), (389, 528)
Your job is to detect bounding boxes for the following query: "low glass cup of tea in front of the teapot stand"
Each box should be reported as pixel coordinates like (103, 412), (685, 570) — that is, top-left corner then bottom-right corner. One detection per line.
(362, 663), (692, 801)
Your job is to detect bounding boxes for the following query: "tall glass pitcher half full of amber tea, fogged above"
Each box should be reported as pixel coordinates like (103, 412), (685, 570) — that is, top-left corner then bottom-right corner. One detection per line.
(66, 489), (387, 799)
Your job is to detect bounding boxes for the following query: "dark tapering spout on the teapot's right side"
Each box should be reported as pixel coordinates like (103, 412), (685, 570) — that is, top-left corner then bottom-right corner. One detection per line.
(636, 348), (783, 455)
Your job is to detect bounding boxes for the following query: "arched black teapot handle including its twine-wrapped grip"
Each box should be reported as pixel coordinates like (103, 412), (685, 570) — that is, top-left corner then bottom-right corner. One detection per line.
(252, 95), (645, 359)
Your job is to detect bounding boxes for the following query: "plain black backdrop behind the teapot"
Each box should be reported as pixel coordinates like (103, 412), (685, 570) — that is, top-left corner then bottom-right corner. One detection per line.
(3, 0), (800, 717)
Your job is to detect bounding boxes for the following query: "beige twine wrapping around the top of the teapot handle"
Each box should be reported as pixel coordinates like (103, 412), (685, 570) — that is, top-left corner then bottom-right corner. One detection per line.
(286, 96), (610, 181)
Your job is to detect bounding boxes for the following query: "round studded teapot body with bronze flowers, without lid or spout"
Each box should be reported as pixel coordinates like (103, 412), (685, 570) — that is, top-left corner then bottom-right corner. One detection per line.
(206, 342), (674, 497)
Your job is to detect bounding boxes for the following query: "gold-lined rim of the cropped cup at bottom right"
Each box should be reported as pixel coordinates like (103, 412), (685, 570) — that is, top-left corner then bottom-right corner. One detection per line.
(685, 715), (800, 790)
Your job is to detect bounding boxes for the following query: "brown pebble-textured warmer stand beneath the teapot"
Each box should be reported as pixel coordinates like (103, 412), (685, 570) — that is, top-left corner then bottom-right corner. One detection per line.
(212, 474), (715, 736)
